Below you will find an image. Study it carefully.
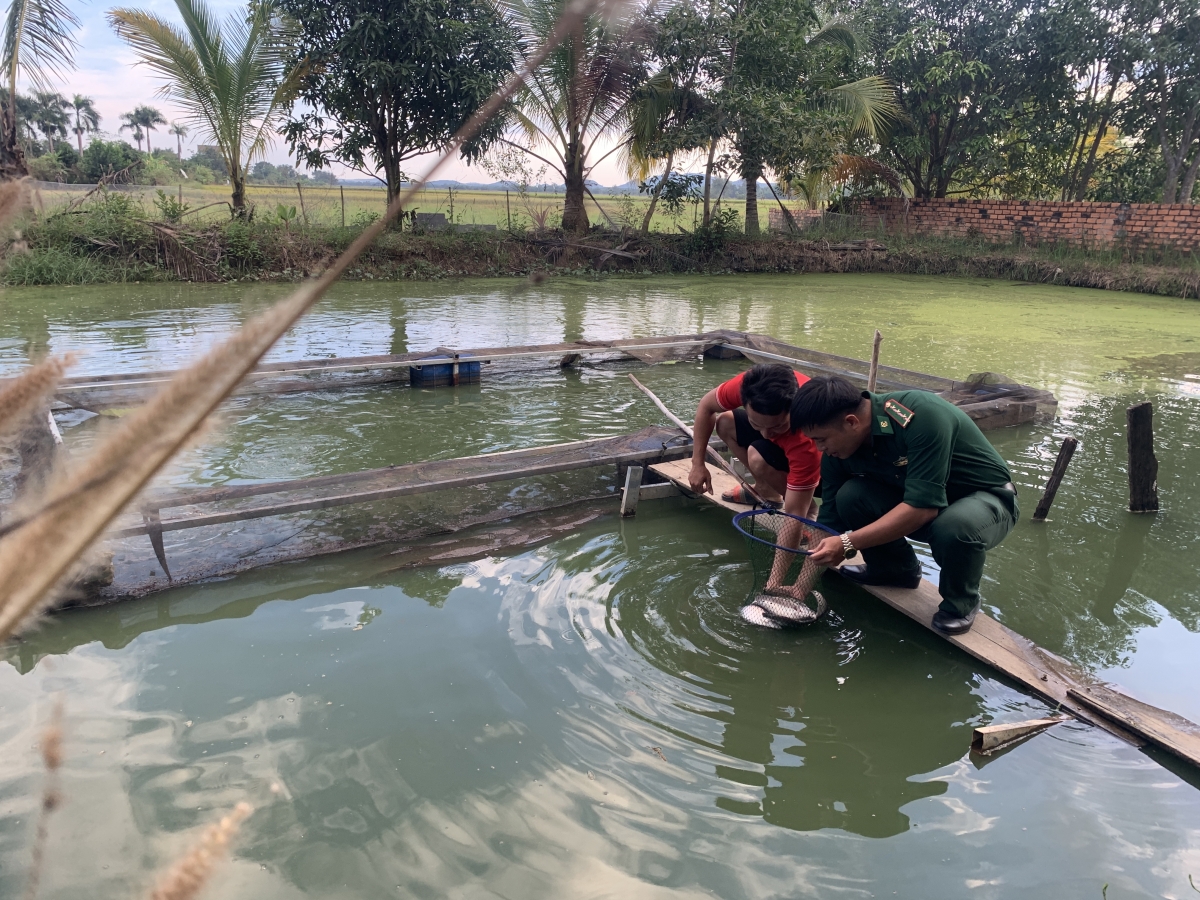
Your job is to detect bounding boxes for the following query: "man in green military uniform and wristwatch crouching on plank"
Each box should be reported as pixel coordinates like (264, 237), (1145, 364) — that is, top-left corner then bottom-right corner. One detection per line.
(792, 377), (1020, 635)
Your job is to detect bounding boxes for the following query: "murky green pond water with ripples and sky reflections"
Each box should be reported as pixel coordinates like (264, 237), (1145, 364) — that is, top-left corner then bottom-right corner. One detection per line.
(0, 276), (1200, 900)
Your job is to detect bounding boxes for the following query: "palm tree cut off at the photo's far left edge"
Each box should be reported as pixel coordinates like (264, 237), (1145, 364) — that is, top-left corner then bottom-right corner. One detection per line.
(0, 0), (79, 179)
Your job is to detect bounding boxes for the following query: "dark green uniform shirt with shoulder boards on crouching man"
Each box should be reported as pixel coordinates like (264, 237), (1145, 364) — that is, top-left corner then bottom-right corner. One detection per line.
(820, 391), (1013, 523)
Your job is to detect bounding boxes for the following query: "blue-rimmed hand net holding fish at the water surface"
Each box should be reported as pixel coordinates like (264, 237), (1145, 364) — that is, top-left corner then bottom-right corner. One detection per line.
(733, 509), (836, 629)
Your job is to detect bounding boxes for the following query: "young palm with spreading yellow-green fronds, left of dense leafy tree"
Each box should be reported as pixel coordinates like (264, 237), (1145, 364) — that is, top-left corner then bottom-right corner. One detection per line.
(108, 0), (300, 211)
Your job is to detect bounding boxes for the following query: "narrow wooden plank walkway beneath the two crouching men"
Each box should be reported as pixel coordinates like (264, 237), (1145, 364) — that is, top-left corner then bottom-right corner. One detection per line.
(649, 460), (1200, 767)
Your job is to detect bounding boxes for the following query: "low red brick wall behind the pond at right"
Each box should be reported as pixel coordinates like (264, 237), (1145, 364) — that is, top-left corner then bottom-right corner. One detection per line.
(847, 198), (1200, 252)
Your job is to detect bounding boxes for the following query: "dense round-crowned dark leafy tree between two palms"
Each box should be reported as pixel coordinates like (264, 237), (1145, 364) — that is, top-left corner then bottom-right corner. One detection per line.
(281, 0), (515, 202)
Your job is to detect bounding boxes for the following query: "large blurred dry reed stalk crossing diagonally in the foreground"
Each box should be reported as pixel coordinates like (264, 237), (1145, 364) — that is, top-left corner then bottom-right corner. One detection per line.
(0, 0), (612, 641)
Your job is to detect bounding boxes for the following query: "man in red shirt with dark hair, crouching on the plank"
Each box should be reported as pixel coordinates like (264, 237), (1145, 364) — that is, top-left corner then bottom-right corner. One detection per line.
(688, 365), (821, 517)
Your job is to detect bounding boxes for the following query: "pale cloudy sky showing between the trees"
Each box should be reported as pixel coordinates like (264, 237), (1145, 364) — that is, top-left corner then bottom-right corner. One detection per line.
(58, 0), (628, 185)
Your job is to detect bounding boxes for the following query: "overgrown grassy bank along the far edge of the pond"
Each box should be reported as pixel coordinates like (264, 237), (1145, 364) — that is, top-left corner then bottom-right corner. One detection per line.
(9, 193), (1200, 298)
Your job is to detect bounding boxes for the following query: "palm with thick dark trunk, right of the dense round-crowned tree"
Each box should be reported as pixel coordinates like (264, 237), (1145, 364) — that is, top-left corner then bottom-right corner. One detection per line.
(503, 0), (644, 233)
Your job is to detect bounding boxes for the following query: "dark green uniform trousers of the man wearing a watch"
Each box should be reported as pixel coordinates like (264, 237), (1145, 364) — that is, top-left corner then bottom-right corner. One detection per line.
(830, 478), (1020, 616)
